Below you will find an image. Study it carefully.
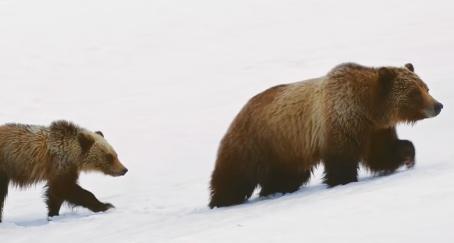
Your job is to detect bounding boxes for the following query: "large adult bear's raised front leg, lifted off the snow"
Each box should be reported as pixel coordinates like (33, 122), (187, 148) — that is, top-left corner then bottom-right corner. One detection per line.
(363, 127), (415, 174)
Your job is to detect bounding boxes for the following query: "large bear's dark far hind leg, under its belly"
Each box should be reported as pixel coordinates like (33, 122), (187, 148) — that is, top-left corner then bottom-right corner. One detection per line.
(260, 167), (311, 197)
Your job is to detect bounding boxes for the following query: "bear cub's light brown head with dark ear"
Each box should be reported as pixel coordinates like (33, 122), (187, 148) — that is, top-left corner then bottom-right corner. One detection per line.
(77, 130), (128, 176)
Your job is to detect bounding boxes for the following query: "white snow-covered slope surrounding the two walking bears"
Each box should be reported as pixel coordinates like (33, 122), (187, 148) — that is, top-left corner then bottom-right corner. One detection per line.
(0, 0), (454, 243)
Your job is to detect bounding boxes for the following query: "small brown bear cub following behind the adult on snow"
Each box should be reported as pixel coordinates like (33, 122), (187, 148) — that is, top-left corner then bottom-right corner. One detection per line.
(0, 121), (127, 221)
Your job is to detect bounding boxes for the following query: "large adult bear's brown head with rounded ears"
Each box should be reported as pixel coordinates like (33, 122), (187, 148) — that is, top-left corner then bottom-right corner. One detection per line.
(378, 63), (443, 126)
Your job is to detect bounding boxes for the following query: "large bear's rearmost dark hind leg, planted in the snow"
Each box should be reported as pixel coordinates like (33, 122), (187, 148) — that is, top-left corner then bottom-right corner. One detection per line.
(209, 162), (257, 208)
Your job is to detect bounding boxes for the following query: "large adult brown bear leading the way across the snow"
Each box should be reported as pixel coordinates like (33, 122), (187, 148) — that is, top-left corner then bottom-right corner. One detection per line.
(209, 63), (442, 208)
